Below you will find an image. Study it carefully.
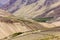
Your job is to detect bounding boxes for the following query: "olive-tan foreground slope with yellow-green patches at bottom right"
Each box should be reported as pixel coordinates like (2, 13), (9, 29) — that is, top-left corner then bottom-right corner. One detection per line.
(3, 27), (60, 40)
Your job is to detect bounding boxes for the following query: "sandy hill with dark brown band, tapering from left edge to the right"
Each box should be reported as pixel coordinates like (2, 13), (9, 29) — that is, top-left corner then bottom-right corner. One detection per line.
(0, 9), (46, 39)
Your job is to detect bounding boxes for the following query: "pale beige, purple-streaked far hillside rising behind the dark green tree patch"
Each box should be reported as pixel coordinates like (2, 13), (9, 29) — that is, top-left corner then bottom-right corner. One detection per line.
(13, 0), (60, 18)
